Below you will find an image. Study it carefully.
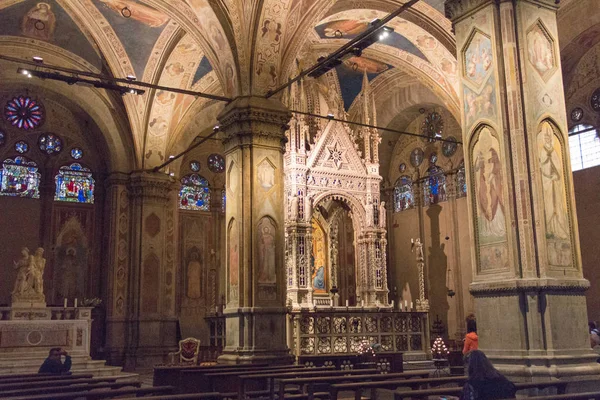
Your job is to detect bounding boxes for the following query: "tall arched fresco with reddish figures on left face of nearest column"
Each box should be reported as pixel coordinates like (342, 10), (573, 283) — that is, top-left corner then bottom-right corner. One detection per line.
(472, 127), (508, 270)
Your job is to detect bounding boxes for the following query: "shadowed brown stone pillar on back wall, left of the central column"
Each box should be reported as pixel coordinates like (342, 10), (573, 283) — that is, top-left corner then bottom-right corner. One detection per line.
(125, 172), (178, 368)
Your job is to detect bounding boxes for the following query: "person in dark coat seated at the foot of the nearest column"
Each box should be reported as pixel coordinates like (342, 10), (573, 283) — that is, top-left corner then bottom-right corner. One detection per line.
(460, 350), (517, 400)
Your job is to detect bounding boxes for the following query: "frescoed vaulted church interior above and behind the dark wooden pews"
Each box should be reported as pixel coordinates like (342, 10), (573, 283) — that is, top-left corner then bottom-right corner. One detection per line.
(0, 0), (600, 394)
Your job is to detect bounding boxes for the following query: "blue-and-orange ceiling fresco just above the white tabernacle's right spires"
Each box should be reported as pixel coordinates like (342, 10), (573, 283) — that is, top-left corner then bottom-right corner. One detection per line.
(336, 57), (393, 111)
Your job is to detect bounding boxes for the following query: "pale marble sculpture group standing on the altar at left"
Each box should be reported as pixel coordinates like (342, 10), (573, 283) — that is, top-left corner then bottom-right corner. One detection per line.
(12, 247), (46, 306)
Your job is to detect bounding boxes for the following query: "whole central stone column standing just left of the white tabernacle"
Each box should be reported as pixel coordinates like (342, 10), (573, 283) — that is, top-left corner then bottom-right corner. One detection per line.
(218, 97), (292, 363)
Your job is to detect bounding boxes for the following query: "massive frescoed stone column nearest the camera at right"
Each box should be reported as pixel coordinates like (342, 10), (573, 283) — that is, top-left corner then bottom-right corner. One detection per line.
(446, 0), (600, 380)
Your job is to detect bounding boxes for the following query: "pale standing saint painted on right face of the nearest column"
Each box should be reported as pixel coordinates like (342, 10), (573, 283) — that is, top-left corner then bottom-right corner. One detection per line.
(538, 122), (570, 239)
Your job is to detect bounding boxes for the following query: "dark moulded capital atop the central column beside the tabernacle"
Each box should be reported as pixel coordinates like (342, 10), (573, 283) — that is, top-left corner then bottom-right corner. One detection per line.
(217, 96), (292, 151)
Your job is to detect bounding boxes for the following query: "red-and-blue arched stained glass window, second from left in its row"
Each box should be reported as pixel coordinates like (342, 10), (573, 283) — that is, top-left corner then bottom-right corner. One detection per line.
(54, 163), (95, 204)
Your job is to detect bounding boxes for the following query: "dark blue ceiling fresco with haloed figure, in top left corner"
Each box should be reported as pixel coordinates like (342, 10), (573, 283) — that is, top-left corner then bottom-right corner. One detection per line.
(0, 0), (102, 68)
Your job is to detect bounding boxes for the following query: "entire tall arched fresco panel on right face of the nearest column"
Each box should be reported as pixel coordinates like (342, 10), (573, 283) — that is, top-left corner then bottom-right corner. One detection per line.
(537, 121), (572, 267)
